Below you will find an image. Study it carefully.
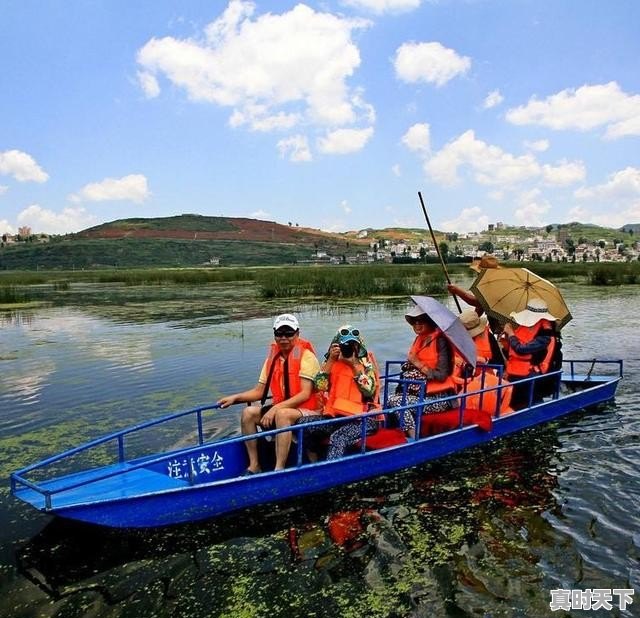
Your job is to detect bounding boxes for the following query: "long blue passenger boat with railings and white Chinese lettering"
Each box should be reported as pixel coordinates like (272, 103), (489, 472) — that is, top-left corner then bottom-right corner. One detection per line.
(11, 360), (623, 528)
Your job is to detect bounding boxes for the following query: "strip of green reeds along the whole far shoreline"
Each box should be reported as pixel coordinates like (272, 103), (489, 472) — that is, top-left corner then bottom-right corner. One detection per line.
(0, 262), (640, 309)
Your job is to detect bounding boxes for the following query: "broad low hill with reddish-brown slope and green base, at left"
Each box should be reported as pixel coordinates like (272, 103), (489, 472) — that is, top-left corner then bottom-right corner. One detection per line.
(0, 215), (367, 270)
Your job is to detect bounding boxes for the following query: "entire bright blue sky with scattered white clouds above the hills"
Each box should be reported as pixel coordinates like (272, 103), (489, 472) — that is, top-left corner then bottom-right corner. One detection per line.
(0, 0), (640, 233)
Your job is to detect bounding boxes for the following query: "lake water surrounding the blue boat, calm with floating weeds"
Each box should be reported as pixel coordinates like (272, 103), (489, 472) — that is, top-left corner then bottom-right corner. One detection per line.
(0, 284), (640, 618)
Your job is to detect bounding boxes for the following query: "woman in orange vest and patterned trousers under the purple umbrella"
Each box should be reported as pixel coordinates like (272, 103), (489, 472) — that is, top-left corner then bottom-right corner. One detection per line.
(387, 305), (456, 437)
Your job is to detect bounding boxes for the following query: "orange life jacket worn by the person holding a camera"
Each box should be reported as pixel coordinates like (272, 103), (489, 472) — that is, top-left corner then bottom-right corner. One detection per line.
(324, 352), (380, 416)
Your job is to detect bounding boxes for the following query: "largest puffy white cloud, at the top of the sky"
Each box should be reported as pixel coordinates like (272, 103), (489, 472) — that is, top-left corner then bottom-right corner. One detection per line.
(137, 0), (372, 130)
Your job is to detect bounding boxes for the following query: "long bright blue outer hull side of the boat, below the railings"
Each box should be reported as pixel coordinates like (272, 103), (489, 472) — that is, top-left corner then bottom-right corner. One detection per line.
(13, 370), (620, 528)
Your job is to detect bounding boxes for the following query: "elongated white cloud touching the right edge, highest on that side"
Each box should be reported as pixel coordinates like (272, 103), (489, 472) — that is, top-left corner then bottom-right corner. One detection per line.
(506, 82), (640, 139)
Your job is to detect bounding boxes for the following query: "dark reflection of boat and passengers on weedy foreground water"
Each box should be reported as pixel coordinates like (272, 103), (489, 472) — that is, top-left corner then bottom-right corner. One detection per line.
(16, 429), (558, 617)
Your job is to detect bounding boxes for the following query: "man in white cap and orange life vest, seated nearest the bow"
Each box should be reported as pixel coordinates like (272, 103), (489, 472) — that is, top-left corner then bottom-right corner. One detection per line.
(218, 313), (321, 474)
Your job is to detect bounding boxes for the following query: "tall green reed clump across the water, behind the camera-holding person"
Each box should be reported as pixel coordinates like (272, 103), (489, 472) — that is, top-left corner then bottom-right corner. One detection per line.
(256, 265), (445, 298)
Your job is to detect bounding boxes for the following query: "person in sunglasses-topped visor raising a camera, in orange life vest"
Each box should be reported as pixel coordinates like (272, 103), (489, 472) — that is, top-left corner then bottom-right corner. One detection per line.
(297, 324), (380, 459)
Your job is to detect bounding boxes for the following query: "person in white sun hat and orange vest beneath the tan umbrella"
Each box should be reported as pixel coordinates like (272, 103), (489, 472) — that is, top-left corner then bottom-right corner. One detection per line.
(504, 297), (560, 410)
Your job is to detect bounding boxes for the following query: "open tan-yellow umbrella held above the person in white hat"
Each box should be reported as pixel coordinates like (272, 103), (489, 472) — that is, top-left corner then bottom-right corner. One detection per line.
(471, 268), (572, 328)
